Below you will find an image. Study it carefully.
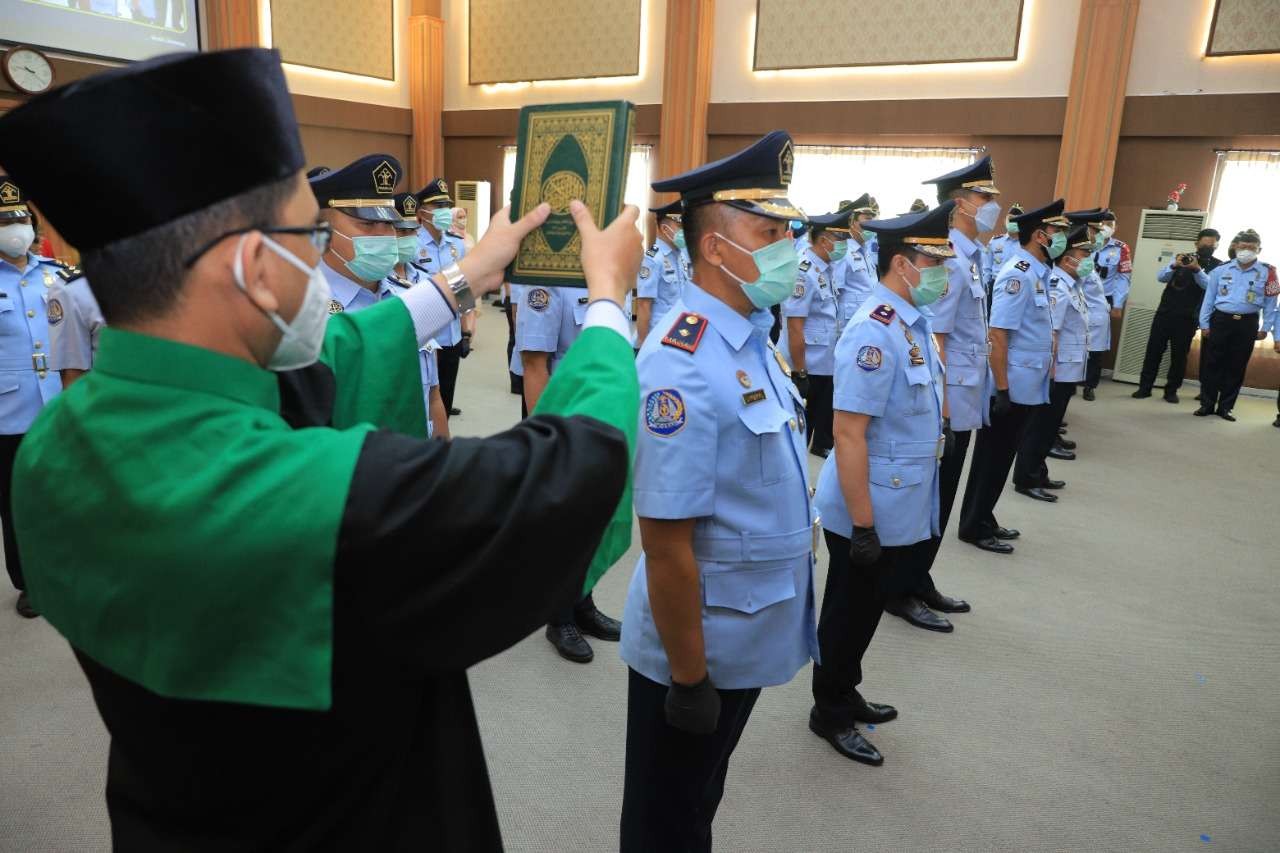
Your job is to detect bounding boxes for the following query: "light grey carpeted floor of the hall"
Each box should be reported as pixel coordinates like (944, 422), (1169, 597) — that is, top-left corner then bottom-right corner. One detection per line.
(0, 311), (1280, 853)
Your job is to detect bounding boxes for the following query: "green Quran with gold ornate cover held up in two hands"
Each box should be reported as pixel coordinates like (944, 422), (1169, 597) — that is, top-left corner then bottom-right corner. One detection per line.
(507, 101), (635, 287)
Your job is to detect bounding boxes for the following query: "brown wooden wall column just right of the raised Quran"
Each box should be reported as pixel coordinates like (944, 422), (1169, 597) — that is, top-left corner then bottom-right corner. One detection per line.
(658, 0), (714, 195)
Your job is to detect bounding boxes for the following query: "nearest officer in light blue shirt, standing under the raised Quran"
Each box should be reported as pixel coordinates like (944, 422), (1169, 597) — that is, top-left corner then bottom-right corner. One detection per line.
(621, 131), (818, 853)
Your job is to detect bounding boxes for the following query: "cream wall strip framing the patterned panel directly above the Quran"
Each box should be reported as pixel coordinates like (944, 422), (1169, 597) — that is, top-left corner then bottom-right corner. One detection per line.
(444, 0), (667, 110)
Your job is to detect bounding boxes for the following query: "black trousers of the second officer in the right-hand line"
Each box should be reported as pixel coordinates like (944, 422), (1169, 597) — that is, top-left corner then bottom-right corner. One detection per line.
(813, 530), (937, 726)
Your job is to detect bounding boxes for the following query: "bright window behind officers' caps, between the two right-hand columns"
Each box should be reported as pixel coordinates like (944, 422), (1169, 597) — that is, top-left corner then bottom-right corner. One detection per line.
(787, 145), (977, 218)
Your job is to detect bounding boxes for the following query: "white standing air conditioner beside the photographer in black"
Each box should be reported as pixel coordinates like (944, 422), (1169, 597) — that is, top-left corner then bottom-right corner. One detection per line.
(1111, 210), (1208, 386)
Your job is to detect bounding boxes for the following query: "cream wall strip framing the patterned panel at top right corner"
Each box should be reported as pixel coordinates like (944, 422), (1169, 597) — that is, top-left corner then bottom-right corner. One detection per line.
(1125, 0), (1280, 95)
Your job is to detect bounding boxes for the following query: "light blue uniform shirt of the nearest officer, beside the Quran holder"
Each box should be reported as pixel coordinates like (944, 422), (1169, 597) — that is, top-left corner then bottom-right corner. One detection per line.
(621, 283), (818, 690)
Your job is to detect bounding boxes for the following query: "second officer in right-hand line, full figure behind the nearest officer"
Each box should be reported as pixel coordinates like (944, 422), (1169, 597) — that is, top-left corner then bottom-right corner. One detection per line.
(809, 201), (956, 766)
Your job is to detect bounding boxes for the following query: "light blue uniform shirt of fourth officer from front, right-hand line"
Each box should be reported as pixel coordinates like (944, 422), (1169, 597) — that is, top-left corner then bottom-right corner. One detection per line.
(991, 246), (1053, 406)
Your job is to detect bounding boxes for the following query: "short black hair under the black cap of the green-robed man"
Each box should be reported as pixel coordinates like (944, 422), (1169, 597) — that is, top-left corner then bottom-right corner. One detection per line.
(81, 174), (297, 325)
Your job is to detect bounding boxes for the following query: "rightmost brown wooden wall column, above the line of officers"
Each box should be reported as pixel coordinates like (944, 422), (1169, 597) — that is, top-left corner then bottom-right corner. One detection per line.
(1056, 0), (1140, 210)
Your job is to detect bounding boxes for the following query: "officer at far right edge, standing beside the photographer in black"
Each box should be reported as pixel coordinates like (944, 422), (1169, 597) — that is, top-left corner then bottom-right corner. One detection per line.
(1194, 228), (1280, 420)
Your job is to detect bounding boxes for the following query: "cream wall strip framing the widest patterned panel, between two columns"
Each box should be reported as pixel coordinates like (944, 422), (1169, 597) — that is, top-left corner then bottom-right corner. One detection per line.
(710, 0), (1080, 102)
